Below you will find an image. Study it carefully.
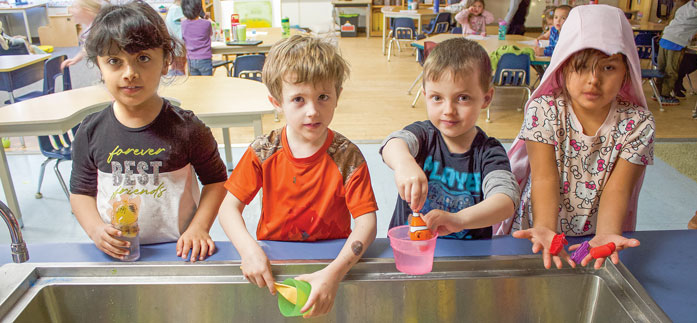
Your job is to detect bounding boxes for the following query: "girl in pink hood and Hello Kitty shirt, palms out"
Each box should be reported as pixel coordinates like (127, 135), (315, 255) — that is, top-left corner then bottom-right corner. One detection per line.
(506, 5), (655, 268)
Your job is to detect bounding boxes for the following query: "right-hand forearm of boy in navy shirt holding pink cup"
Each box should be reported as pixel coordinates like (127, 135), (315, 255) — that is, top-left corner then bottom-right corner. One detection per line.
(456, 193), (515, 230)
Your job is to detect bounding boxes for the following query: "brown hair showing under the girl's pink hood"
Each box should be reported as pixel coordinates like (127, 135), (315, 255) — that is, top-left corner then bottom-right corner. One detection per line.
(555, 48), (630, 98)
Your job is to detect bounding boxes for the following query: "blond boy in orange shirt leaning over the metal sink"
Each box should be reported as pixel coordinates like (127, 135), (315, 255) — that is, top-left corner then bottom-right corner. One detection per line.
(220, 35), (377, 317)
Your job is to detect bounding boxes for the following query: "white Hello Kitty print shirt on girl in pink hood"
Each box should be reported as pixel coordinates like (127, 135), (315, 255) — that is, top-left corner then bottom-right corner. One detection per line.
(512, 95), (655, 236)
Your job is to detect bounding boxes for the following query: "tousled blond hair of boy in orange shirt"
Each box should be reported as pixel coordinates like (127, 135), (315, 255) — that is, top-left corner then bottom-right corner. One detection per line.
(262, 35), (349, 102)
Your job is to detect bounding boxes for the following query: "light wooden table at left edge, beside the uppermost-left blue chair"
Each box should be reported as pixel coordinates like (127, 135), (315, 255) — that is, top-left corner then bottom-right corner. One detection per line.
(0, 54), (51, 103)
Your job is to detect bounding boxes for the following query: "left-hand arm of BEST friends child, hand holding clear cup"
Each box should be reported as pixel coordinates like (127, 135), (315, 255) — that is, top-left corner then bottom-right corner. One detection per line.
(70, 194), (129, 259)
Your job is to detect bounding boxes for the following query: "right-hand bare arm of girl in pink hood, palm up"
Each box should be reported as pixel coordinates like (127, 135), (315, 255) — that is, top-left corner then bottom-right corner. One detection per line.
(569, 158), (646, 269)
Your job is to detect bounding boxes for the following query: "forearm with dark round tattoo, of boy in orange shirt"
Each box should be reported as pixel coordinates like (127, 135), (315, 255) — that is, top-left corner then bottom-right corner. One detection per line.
(320, 212), (377, 279)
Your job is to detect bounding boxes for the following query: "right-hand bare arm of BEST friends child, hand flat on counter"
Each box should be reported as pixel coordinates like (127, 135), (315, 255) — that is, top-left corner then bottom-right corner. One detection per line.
(177, 182), (227, 262)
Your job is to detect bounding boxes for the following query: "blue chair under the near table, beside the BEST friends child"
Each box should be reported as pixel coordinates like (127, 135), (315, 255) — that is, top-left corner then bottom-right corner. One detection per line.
(34, 124), (80, 201)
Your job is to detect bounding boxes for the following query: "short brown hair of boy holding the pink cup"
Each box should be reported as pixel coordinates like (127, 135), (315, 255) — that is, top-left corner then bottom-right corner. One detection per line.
(424, 37), (491, 91)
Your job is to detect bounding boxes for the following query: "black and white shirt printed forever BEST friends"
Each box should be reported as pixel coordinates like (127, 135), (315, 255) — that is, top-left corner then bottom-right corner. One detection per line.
(70, 100), (227, 244)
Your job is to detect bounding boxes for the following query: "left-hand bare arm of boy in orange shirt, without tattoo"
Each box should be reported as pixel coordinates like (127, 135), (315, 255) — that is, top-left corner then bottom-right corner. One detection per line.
(219, 193), (276, 295)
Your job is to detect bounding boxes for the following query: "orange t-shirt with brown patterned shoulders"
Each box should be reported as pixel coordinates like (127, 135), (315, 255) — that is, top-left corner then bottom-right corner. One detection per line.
(225, 128), (378, 241)
